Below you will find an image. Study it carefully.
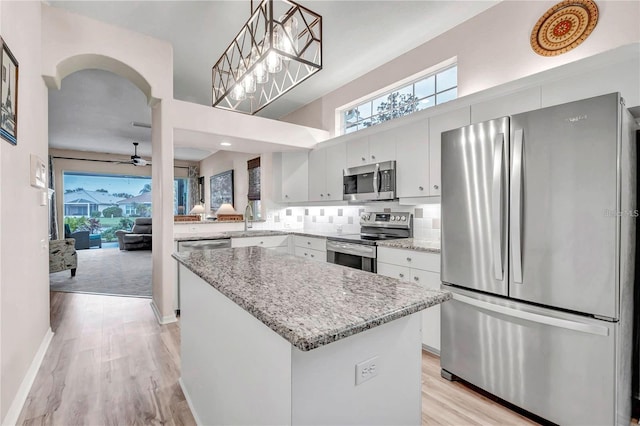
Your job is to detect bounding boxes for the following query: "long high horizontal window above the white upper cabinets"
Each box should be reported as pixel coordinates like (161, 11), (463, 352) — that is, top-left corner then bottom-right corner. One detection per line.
(341, 65), (458, 134)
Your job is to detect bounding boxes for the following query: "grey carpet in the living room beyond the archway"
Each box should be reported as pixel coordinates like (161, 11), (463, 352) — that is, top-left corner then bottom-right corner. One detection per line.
(49, 248), (152, 298)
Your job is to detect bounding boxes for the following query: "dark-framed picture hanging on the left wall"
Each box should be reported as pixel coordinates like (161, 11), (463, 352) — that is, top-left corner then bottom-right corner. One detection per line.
(0, 37), (18, 145)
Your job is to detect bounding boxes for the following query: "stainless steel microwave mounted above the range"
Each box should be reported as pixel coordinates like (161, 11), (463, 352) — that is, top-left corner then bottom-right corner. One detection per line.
(342, 161), (396, 201)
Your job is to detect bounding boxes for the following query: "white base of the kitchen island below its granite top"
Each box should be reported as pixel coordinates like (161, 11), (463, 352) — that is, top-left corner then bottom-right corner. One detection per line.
(179, 265), (421, 425)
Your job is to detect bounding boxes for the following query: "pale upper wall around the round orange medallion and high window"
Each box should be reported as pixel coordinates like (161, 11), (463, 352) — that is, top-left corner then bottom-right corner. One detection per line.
(282, 0), (640, 134)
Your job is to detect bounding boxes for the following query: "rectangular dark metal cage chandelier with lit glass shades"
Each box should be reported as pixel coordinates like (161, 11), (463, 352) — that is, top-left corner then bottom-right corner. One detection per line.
(212, 0), (322, 114)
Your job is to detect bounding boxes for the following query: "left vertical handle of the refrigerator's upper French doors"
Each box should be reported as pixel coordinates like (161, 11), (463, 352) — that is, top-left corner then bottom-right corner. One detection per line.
(491, 133), (504, 281)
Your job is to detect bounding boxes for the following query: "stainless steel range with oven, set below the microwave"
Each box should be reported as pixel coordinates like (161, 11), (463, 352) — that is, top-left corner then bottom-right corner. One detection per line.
(327, 212), (413, 272)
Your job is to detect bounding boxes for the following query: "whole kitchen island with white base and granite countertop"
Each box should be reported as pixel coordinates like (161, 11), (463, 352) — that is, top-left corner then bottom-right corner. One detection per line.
(174, 247), (451, 424)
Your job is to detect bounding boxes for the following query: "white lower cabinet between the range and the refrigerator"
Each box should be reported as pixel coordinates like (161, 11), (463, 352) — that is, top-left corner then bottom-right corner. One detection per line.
(378, 247), (440, 354)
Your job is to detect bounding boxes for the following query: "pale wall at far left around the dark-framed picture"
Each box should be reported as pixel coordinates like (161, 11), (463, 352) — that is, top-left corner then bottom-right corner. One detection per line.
(0, 1), (49, 424)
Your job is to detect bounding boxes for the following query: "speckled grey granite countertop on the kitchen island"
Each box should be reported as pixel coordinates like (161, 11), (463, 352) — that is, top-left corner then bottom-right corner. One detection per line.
(173, 247), (451, 351)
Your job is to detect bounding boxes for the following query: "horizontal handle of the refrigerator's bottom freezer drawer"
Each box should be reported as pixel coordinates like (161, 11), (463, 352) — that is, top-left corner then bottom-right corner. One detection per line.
(453, 293), (609, 336)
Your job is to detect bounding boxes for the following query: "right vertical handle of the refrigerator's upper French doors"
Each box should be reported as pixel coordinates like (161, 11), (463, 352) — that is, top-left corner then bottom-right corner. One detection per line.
(510, 129), (523, 283)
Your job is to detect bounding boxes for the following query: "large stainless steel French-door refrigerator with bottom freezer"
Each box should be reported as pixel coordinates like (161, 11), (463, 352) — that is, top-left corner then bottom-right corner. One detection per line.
(441, 93), (637, 425)
